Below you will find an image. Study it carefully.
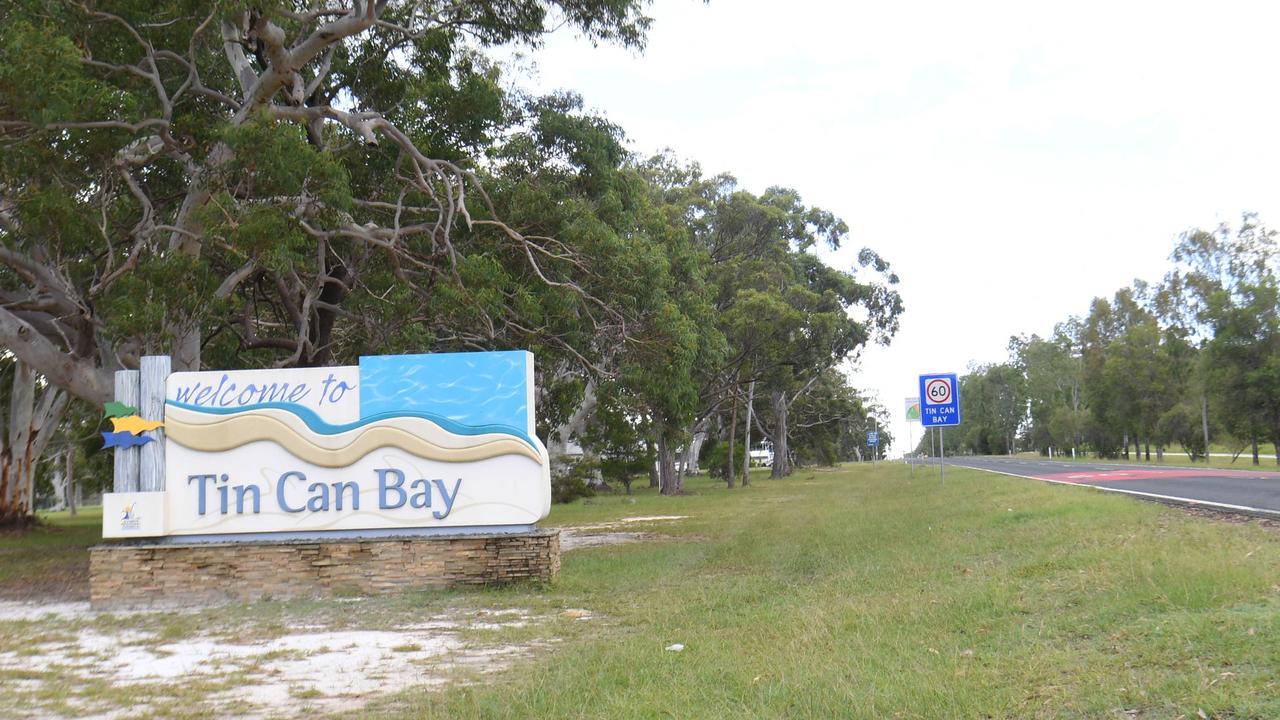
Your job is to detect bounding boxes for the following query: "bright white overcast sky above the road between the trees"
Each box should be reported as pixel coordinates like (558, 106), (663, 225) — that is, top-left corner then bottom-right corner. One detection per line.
(514, 0), (1280, 454)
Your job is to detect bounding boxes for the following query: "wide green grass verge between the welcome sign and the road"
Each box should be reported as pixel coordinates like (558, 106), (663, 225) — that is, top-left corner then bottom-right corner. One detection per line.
(361, 464), (1280, 719)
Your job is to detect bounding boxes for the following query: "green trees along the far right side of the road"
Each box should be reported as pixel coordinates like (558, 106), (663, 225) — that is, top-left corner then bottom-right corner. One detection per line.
(962, 214), (1280, 462)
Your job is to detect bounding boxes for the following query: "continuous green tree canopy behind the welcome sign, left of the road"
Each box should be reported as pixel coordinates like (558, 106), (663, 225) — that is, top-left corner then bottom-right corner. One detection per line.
(0, 0), (902, 515)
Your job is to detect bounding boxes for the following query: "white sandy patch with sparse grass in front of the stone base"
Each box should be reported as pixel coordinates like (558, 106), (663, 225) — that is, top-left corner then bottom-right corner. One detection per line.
(0, 603), (560, 719)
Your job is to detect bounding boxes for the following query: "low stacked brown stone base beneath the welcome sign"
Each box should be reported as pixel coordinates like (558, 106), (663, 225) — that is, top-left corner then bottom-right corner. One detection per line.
(90, 529), (559, 610)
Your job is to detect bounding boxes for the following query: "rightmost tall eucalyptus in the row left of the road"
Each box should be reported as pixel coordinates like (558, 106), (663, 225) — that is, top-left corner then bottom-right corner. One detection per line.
(695, 176), (902, 478)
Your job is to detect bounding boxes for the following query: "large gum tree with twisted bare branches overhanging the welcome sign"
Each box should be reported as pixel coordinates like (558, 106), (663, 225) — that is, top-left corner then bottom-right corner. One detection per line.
(0, 0), (649, 520)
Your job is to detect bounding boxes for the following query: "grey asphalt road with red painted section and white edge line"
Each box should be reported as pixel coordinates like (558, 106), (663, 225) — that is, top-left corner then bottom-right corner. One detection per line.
(931, 456), (1280, 515)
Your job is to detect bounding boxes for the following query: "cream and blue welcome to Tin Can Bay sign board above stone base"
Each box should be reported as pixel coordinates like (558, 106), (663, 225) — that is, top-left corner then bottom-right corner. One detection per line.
(102, 351), (550, 538)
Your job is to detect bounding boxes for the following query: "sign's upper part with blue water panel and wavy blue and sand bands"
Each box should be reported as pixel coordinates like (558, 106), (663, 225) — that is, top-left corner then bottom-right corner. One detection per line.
(165, 351), (541, 468)
